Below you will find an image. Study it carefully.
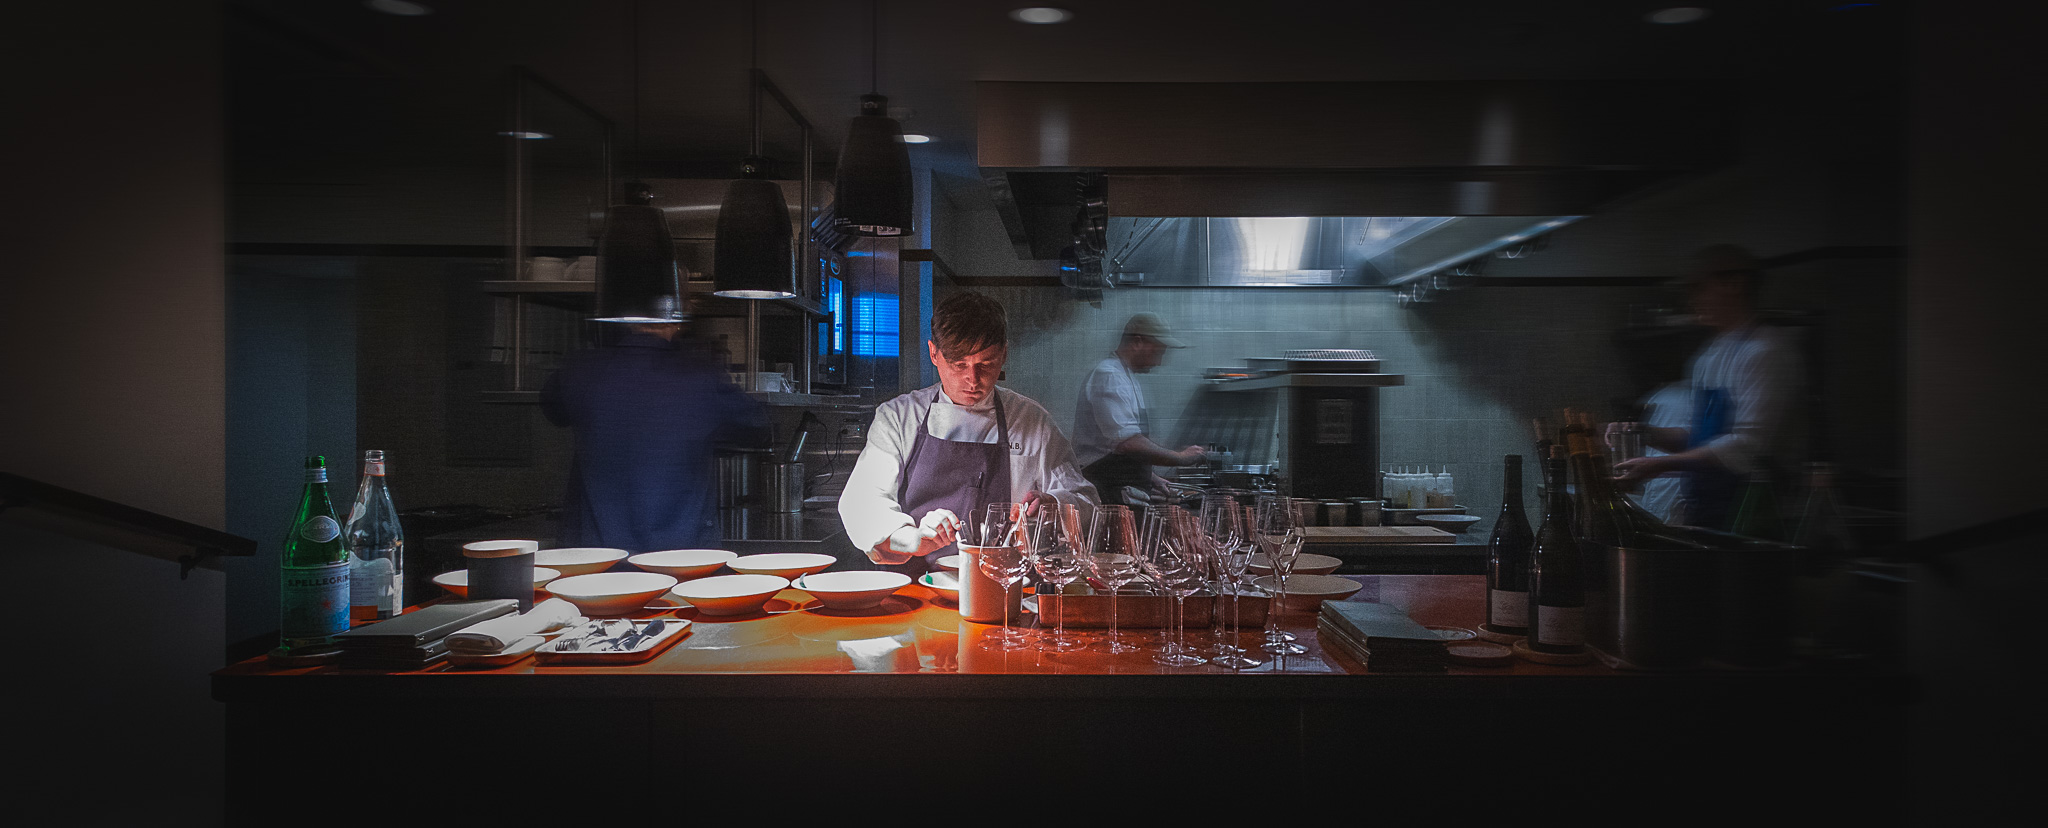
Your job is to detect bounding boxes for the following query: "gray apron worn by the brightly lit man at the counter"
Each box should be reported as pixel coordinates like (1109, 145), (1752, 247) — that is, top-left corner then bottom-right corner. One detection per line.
(877, 389), (1010, 578)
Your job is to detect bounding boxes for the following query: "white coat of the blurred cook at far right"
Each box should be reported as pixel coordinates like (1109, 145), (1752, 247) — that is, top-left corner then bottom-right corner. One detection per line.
(1688, 324), (1804, 473)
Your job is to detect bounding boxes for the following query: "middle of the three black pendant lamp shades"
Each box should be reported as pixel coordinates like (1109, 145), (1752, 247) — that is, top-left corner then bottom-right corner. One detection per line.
(711, 156), (797, 299)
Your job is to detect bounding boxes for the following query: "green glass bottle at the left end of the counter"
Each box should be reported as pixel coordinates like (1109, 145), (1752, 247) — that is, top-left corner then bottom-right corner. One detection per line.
(279, 455), (348, 652)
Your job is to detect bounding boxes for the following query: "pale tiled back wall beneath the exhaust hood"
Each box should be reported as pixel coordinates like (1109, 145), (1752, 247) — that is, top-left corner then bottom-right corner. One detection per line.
(950, 287), (1661, 531)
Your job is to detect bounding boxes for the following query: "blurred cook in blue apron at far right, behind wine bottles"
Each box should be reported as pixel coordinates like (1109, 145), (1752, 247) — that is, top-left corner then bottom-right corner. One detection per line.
(1616, 244), (1804, 529)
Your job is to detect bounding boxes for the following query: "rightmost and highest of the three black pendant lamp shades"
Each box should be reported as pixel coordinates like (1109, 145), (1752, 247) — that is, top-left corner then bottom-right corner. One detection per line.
(831, 94), (913, 236)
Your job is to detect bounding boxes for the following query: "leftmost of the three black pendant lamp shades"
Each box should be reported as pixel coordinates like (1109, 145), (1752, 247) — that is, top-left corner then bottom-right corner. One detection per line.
(596, 182), (690, 322)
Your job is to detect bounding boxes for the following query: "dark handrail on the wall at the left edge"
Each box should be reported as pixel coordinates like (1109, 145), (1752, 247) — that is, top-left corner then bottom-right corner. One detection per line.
(0, 471), (256, 580)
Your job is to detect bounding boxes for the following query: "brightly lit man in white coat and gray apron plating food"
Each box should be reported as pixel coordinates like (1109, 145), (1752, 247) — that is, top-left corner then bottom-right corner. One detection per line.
(840, 293), (1096, 578)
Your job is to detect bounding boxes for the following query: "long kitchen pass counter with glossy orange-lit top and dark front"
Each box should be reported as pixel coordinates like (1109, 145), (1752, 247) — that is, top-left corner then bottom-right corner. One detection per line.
(213, 576), (1913, 822)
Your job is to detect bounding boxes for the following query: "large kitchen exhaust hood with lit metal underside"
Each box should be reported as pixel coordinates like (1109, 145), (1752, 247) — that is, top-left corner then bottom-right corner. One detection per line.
(975, 80), (1735, 287)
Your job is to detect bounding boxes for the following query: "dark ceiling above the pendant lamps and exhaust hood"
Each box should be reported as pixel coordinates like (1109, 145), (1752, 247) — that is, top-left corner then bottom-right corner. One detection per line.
(227, 0), (1903, 178)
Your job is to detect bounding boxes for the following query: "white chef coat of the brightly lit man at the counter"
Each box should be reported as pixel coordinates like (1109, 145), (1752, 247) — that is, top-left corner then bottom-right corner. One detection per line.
(840, 385), (1096, 551)
